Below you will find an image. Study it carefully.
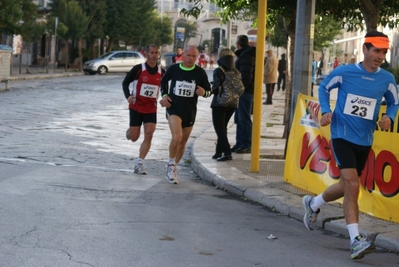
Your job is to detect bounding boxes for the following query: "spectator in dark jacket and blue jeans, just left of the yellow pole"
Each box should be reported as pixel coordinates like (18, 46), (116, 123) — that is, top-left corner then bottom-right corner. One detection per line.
(231, 35), (255, 154)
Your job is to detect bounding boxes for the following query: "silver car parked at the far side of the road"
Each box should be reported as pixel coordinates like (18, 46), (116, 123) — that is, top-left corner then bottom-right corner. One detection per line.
(83, 51), (145, 75)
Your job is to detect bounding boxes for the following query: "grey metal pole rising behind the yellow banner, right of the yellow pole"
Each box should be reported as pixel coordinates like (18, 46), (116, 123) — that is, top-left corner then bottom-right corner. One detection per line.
(290, 0), (316, 125)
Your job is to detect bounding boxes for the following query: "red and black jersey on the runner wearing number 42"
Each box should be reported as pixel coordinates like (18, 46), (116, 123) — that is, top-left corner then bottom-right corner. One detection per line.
(122, 63), (164, 114)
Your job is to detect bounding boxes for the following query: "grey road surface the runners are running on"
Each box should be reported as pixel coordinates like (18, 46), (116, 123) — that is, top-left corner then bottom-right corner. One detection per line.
(0, 75), (399, 267)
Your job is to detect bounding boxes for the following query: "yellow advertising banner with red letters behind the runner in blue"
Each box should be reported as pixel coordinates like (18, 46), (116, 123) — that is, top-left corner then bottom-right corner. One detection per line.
(284, 95), (399, 223)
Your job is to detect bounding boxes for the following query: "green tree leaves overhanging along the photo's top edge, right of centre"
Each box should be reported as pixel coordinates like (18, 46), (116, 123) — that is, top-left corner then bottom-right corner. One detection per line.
(182, 0), (399, 31)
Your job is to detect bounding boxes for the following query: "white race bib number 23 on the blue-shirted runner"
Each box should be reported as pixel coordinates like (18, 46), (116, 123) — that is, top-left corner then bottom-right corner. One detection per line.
(344, 94), (377, 120)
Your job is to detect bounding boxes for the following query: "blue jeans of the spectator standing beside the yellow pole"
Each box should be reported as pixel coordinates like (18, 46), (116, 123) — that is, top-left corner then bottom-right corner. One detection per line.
(234, 92), (254, 149)
